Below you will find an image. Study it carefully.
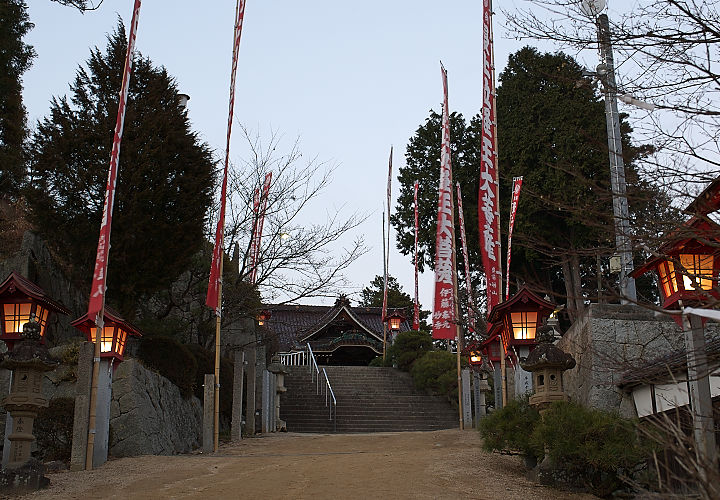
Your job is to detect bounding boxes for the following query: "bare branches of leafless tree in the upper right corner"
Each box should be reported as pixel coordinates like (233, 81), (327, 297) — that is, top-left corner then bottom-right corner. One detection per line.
(503, 0), (720, 202)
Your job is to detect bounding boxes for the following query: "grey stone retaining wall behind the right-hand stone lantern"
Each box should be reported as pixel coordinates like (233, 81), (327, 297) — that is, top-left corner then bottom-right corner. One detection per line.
(558, 304), (717, 417)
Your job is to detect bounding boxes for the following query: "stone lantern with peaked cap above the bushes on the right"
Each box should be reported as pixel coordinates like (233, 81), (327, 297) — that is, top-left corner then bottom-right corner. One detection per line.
(520, 326), (575, 412)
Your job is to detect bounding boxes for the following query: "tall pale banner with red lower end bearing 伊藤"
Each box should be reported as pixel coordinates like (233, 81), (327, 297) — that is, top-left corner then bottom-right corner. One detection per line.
(432, 68), (457, 339)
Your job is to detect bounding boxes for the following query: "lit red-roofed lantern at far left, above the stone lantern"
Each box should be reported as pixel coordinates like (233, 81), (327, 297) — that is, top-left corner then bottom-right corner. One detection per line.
(0, 273), (70, 350)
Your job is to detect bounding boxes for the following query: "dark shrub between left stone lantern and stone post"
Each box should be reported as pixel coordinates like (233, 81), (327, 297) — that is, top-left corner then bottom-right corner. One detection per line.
(33, 398), (75, 462)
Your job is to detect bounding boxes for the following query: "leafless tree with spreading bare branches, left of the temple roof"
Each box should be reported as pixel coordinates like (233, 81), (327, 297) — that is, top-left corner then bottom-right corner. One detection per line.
(219, 127), (366, 303)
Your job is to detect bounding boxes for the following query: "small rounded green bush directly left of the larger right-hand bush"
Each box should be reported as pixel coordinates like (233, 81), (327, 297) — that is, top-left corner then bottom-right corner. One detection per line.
(479, 397), (542, 459)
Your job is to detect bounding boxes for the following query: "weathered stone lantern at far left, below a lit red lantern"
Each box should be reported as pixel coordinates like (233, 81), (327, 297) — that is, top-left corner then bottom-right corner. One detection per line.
(0, 340), (57, 493)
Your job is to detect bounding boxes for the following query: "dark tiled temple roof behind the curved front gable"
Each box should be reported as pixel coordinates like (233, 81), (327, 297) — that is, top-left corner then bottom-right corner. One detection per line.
(265, 300), (410, 351)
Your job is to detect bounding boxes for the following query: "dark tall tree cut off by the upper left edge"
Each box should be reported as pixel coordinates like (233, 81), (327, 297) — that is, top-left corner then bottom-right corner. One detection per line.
(0, 0), (35, 198)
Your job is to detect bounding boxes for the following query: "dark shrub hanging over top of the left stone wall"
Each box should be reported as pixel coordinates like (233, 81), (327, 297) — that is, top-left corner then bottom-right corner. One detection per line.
(137, 336), (198, 398)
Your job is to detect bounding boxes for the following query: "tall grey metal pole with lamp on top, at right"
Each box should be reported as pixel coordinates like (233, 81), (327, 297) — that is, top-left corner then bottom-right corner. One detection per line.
(580, 0), (637, 303)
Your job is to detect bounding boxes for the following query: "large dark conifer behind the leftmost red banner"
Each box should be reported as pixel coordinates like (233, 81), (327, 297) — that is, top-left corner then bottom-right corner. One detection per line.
(27, 22), (214, 317)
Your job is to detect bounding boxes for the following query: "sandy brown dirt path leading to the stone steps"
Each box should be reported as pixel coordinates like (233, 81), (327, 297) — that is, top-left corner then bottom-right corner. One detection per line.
(22, 430), (595, 500)
